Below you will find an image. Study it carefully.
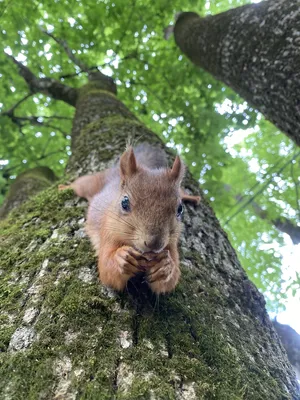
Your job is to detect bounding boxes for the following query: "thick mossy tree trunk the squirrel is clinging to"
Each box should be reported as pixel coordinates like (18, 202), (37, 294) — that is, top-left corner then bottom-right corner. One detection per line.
(0, 72), (300, 400)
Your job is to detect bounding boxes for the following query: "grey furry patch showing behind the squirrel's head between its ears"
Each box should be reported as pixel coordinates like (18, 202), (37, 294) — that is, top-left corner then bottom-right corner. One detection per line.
(133, 143), (168, 169)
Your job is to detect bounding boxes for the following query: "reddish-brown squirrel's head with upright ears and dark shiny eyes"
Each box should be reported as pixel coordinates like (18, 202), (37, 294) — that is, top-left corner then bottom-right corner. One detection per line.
(114, 148), (184, 253)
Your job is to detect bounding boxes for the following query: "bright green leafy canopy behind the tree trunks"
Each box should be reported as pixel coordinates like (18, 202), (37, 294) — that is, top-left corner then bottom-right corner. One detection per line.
(0, 0), (299, 309)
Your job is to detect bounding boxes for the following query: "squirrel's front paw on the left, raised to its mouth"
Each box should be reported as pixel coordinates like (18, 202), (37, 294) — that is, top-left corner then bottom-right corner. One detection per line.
(115, 246), (144, 278)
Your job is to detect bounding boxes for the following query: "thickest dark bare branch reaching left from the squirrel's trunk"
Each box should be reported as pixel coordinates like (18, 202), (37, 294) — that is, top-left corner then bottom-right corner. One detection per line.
(5, 53), (78, 107)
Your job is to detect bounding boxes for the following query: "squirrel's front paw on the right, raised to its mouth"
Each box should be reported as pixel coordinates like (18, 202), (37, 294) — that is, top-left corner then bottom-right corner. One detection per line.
(147, 250), (180, 293)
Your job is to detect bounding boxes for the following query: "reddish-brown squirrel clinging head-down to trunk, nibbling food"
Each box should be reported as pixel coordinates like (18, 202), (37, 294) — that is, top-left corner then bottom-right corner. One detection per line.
(59, 144), (200, 294)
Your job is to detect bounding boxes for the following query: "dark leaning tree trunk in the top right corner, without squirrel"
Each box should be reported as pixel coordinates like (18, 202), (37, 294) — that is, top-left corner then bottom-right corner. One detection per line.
(174, 0), (300, 146)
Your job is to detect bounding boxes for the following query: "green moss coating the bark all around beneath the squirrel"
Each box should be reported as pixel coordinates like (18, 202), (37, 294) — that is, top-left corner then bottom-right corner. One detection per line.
(0, 158), (296, 400)
